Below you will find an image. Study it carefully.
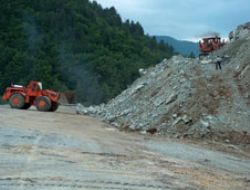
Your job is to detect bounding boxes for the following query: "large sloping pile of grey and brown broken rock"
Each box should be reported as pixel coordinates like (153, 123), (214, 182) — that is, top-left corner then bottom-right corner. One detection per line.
(77, 23), (250, 143)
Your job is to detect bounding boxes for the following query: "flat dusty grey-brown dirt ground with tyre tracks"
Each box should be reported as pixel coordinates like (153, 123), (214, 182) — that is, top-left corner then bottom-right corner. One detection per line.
(0, 106), (250, 190)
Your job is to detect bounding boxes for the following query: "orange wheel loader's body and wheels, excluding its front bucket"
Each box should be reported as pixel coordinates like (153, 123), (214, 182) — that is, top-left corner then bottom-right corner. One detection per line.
(2, 81), (60, 111)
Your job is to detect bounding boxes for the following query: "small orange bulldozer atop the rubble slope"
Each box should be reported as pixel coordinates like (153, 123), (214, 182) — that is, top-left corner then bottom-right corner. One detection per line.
(199, 36), (224, 56)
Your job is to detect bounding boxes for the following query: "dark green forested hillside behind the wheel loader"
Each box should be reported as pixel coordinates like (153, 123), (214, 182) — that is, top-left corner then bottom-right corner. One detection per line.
(0, 0), (173, 104)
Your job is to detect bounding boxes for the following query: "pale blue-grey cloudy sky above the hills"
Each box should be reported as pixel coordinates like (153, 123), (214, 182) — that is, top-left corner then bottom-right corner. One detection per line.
(92, 0), (250, 40)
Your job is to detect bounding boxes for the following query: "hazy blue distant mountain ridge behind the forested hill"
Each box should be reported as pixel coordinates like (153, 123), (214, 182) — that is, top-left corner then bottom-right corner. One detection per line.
(155, 36), (199, 56)
